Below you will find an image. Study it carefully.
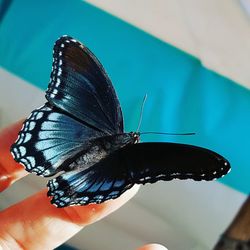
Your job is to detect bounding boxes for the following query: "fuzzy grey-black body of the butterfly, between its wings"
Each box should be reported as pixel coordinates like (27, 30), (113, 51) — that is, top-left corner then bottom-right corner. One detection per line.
(69, 132), (140, 170)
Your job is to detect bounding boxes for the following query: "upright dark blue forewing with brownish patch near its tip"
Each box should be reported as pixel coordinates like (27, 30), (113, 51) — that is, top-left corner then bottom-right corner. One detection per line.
(46, 36), (123, 135)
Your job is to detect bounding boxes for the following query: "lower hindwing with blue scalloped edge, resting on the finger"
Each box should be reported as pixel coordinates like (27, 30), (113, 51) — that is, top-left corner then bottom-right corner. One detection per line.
(48, 153), (133, 207)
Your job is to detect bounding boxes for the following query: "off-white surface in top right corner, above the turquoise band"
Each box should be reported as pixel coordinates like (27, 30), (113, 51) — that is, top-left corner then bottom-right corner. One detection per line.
(87, 0), (250, 88)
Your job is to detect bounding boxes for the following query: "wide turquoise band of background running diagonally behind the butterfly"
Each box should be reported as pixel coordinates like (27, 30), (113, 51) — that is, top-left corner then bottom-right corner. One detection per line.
(0, 0), (250, 194)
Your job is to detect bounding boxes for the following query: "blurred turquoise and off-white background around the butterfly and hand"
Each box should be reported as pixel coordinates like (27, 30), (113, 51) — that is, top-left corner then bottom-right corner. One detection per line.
(0, 0), (250, 250)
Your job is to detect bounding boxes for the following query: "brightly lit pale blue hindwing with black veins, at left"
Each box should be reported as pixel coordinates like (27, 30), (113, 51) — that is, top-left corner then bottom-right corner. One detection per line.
(11, 104), (104, 177)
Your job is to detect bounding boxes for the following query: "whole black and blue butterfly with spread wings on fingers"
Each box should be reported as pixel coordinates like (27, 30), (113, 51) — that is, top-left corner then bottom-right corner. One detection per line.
(11, 36), (230, 207)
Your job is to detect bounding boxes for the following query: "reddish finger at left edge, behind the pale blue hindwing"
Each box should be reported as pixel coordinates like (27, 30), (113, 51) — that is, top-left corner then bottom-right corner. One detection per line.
(0, 121), (28, 192)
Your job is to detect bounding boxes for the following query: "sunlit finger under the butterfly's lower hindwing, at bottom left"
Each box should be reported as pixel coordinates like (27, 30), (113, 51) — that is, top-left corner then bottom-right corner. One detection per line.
(0, 186), (138, 249)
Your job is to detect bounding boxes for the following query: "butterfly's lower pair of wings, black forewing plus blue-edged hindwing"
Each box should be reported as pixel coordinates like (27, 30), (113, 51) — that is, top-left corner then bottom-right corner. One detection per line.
(48, 143), (230, 207)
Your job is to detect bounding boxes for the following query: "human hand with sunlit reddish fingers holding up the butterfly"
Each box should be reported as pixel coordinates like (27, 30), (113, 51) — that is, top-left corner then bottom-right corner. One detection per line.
(0, 121), (166, 250)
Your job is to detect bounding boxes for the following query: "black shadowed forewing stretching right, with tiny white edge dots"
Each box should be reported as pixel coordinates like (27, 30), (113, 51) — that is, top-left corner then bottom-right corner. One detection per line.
(117, 143), (230, 184)
